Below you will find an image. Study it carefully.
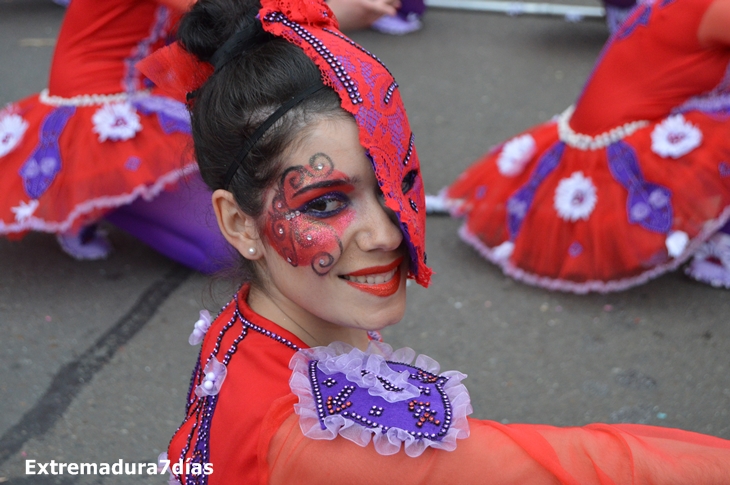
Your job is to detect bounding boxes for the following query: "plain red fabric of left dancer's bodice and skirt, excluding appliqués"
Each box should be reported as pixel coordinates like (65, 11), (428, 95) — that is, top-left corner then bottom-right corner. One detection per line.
(0, 0), (197, 236)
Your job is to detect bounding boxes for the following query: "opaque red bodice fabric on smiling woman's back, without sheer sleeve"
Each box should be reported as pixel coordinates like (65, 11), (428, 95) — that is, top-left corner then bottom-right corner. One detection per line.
(168, 287), (307, 485)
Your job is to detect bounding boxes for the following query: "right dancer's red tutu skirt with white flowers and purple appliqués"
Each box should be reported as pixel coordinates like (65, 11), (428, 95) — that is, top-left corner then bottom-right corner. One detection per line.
(445, 107), (730, 293)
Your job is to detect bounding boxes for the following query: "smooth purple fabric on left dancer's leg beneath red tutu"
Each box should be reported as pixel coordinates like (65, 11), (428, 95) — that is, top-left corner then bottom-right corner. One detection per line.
(106, 176), (233, 273)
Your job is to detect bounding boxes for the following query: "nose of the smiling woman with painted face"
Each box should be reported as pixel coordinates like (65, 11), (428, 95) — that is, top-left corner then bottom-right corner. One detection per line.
(356, 191), (403, 251)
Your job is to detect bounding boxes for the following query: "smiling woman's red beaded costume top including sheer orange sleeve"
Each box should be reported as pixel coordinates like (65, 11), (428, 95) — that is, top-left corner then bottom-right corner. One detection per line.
(168, 287), (730, 485)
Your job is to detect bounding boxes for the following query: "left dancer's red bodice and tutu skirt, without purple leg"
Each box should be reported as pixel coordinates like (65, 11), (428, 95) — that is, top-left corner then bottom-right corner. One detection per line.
(0, 0), (196, 236)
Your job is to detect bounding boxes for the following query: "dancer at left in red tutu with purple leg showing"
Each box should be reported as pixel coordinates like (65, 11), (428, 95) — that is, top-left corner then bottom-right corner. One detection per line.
(0, 0), (230, 272)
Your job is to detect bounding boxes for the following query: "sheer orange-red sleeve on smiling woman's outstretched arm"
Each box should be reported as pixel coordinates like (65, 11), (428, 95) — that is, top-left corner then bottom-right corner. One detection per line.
(259, 396), (730, 485)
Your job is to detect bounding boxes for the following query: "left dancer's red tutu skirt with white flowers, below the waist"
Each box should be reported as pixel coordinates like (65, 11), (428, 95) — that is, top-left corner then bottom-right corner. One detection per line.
(0, 89), (197, 237)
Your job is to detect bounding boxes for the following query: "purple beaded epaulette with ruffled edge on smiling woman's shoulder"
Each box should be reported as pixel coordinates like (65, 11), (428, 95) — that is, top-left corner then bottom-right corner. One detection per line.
(289, 342), (472, 456)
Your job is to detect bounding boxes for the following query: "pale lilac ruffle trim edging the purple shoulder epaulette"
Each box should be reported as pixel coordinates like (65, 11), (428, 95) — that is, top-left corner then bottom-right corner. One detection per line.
(289, 341), (472, 458)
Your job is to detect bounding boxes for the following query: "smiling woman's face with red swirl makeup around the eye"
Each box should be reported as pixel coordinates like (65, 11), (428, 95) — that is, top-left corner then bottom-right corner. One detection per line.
(261, 117), (409, 343)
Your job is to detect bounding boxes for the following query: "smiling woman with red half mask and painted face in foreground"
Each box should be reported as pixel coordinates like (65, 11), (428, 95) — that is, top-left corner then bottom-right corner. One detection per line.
(140, 0), (730, 485)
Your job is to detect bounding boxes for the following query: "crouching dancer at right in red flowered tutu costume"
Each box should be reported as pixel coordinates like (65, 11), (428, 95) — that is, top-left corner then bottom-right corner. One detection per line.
(442, 0), (730, 293)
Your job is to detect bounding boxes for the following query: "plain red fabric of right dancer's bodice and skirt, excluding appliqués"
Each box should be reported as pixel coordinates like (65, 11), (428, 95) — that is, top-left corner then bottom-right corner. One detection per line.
(447, 0), (730, 292)
